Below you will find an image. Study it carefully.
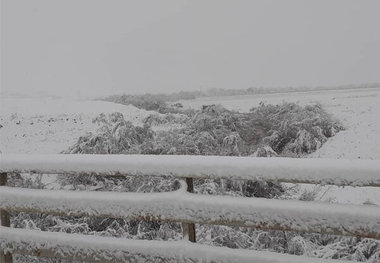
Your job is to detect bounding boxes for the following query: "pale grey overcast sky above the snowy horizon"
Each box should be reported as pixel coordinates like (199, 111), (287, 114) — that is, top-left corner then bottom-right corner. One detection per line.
(1, 0), (380, 96)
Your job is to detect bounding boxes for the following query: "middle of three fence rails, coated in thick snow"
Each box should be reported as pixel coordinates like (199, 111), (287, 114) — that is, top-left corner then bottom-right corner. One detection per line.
(0, 186), (380, 238)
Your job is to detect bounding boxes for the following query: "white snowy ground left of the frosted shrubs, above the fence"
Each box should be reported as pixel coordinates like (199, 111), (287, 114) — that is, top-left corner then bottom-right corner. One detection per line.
(0, 98), (151, 154)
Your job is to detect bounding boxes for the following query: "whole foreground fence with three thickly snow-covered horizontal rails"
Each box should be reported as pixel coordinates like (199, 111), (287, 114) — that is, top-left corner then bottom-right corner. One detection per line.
(0, 155), (380, 262)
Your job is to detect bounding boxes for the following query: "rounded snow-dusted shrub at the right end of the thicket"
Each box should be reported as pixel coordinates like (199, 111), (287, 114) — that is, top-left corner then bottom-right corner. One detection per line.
(255, 103), (343, 157)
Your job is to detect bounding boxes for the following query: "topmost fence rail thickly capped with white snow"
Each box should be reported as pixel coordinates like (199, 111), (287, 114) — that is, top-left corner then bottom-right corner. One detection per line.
(0, 154), (380, 186)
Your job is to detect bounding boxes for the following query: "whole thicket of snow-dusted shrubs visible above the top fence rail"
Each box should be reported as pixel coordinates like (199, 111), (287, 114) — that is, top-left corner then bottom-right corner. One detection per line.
(66, 103), (343, 157)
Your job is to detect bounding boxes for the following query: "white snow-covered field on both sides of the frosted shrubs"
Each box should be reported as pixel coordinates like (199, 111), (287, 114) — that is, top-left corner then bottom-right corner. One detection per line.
(0, 88), (380, 205)
